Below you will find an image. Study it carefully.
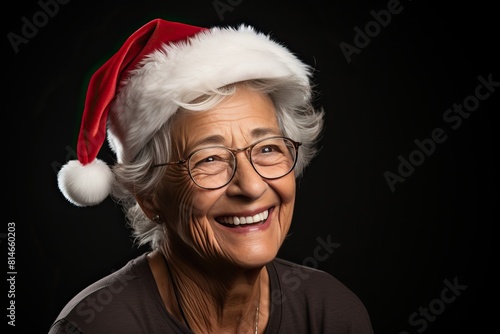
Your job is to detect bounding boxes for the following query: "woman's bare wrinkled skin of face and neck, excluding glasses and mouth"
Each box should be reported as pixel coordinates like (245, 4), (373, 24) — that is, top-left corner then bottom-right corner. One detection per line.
(142, 86), (296, 333)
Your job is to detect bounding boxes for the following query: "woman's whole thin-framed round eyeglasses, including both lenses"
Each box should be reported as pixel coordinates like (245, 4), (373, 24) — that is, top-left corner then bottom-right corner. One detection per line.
(153, 136), (302, 190)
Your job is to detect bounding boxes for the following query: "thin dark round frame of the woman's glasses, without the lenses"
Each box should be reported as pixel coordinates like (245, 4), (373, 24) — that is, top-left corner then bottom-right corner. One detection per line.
(152, 136), (302, 190)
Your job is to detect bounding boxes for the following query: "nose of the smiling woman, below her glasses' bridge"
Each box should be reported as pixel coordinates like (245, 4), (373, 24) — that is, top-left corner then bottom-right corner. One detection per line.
(226, 152), (267, 198)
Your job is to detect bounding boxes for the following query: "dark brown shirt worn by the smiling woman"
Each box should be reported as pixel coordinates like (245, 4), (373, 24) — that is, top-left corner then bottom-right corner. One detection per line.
(49, 254), (373, 334)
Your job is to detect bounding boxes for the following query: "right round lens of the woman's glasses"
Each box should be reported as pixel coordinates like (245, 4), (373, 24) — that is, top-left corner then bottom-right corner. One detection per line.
(251, 138), (297, 179)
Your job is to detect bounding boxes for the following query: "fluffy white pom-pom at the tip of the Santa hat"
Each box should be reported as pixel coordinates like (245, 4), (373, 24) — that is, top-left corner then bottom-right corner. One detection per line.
(57, 159), (113, 206)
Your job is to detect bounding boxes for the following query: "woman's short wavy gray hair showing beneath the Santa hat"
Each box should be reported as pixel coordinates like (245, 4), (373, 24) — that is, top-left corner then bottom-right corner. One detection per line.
(112, 77), (324, 249)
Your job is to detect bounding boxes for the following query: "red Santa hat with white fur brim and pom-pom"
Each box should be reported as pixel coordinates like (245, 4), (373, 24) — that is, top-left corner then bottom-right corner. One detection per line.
(58, 19), (311, 206)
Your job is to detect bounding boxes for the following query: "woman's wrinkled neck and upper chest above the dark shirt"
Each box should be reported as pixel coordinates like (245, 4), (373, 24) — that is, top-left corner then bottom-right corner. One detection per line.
(149, 252), (267, 333)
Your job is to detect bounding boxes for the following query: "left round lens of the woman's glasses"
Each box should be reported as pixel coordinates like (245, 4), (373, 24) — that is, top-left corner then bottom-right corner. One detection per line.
(188, 147), (235, 189)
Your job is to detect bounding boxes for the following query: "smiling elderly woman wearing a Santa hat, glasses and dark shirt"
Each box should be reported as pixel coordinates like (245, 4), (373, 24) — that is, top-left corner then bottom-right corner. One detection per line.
(49, 19), (373, 334)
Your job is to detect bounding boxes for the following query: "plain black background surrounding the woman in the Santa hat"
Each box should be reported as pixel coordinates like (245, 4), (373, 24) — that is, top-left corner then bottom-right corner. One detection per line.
(0, 0), (500, 334)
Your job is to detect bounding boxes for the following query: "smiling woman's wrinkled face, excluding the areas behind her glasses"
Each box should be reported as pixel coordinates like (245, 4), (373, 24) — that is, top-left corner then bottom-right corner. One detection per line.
(155, 86), (295, 267)
